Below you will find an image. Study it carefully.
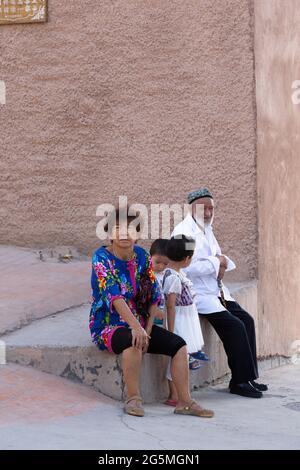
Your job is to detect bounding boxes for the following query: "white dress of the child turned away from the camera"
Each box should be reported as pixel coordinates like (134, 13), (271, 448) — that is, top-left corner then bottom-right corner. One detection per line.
(162, 268), (204, 354)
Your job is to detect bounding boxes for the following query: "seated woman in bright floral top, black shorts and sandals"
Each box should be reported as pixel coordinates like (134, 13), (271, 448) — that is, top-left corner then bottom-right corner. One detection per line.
(90, 210), (213, 418)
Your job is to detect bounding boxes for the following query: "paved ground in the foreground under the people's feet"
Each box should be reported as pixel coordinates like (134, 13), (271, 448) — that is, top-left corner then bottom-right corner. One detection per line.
(0, 364), (300, 450)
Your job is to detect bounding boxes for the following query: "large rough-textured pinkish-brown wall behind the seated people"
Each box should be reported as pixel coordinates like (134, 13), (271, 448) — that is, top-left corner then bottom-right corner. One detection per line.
(0, 0), (257, 278)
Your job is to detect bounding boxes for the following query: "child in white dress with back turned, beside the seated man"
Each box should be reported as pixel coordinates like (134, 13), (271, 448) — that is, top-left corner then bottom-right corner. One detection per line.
(162, 235), (208, 406)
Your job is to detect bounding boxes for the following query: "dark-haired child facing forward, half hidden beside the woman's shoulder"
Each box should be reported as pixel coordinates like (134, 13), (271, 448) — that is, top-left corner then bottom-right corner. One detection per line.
(150, 238), (169, 326)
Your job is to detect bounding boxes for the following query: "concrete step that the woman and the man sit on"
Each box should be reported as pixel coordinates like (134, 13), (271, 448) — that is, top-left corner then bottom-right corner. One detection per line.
(1, 283), (256, 403)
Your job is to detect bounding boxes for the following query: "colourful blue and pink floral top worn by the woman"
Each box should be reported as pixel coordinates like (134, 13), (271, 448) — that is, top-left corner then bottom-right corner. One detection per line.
(89, 245), (160, 352)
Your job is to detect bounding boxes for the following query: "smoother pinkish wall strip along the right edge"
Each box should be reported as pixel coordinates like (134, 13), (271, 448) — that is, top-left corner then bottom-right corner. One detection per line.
(255, 0), (300, 355)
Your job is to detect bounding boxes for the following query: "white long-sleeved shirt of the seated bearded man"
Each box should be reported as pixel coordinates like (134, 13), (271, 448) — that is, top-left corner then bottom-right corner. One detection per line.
(172, 214), (236, 314)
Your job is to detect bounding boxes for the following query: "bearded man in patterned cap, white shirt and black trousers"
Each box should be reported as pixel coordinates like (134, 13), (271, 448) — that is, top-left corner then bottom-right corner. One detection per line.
(172, 188), (268, 398)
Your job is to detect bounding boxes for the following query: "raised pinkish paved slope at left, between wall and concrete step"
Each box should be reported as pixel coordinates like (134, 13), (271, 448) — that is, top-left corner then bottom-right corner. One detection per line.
(0, 245), (91, 334)
